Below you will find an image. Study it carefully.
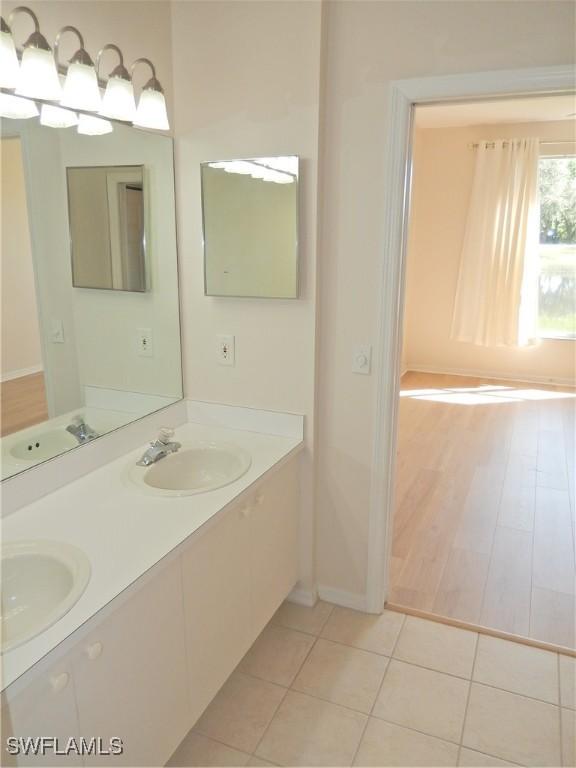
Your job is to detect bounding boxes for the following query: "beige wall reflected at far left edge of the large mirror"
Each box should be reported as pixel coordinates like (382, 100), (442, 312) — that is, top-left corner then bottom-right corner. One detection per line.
(0, 138), (42, 380)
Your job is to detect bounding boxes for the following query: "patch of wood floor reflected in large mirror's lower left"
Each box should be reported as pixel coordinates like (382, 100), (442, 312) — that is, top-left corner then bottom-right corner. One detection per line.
(0, 373), (48, 435)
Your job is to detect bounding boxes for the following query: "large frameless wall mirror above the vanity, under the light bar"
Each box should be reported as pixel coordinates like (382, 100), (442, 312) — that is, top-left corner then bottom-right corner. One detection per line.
(0, 120), (182, 478)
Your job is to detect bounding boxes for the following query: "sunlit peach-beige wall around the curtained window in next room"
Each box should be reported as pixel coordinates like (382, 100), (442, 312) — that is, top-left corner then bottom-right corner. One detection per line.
(404, 121), (576, 382)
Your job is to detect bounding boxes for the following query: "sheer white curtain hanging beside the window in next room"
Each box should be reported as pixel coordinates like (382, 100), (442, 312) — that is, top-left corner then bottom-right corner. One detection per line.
(452, 139), (539, 347)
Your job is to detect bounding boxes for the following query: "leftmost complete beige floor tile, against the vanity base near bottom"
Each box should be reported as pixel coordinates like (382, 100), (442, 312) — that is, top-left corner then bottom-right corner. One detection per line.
(194, 672), (286, 753)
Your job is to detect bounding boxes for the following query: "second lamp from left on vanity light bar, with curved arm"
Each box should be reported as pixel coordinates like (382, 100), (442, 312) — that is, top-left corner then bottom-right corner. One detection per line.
(8, 6), (62, 101)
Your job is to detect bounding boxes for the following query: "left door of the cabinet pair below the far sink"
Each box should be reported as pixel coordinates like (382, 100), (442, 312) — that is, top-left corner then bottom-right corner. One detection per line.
(182, 504), (254, 722)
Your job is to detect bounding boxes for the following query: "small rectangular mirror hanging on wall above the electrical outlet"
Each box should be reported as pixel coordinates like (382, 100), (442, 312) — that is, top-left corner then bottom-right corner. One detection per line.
(201, 155), (298, 299)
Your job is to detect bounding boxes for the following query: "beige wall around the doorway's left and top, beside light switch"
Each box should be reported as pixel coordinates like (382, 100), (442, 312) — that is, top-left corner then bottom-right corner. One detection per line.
(316, 0), (574, 595)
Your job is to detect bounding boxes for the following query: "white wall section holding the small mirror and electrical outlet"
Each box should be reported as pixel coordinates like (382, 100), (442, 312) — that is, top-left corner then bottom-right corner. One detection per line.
(172, 2), (321, 584)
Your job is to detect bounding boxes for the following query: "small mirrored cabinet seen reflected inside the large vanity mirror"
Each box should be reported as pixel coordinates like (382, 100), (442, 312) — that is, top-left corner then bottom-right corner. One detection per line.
(66, 166), (146, 292)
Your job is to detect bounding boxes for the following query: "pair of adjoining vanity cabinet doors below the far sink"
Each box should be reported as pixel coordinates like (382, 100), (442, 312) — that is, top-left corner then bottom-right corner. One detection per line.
(182, 460), (299, 722)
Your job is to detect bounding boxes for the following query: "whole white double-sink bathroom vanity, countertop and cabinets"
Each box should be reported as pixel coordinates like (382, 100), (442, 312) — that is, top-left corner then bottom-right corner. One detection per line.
(2, 404), (302, 765)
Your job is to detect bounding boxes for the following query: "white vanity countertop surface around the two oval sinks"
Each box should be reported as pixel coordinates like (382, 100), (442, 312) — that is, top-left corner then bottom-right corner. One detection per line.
(2, 424), (302, 689)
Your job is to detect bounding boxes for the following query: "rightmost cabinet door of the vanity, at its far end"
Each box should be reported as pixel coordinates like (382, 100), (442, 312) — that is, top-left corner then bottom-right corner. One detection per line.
(249, 458), (300, 637)
